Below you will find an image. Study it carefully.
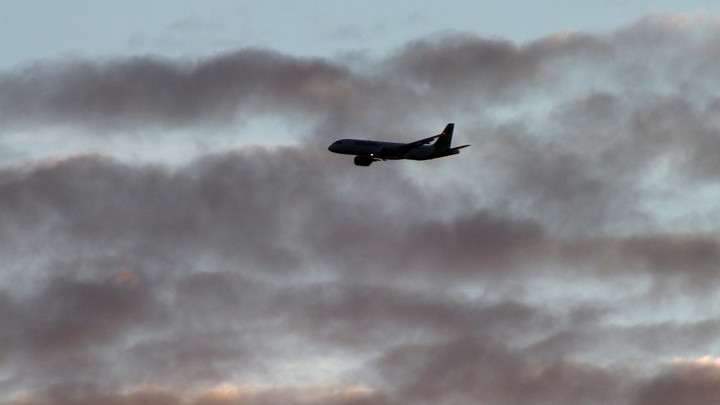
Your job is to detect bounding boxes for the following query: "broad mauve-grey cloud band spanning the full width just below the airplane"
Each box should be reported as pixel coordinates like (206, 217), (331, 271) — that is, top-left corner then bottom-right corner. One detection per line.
(0, 148), (718, 285)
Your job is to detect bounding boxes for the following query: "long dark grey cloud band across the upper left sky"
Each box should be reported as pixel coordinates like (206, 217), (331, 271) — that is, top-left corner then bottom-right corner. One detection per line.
(0, 50), (356, 129)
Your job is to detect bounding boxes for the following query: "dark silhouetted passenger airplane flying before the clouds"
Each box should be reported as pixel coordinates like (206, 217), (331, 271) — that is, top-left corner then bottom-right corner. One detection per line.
(328, 123), (470, 166)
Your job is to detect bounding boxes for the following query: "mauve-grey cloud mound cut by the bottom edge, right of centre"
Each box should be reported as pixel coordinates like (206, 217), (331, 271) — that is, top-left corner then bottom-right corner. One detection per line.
(374, 339), (632, 404)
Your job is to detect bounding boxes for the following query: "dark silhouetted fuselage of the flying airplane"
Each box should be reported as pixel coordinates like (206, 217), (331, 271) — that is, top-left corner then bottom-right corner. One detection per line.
(328, 139), (447, 160)
